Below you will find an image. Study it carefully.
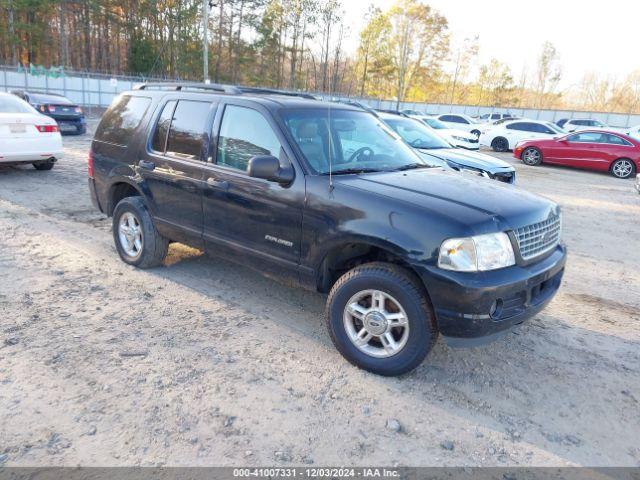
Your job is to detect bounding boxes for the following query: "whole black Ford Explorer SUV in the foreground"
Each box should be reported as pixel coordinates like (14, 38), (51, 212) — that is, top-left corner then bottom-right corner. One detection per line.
(89, 84), (566, 375)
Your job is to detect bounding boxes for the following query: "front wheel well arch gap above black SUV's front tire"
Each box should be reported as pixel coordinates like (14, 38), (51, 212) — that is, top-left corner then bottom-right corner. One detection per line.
(317, 243), (426, 293)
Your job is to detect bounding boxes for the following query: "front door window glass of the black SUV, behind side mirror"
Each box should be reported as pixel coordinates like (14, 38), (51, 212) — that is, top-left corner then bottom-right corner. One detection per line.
(217, 105), (282, 172)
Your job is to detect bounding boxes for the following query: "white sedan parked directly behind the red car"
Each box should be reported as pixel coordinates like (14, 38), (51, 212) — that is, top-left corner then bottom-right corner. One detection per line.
(480, 119), (566, 152)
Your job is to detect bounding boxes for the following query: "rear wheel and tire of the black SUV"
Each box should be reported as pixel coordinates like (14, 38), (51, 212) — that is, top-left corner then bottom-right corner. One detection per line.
(113, 197), (169, 268)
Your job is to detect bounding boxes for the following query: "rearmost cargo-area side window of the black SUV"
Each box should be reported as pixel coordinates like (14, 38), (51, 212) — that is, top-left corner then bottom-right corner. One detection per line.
(96, 95), (151, 146)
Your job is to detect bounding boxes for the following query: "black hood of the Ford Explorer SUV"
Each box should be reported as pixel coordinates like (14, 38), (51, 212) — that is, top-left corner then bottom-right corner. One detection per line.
(334, 168), (558, 235)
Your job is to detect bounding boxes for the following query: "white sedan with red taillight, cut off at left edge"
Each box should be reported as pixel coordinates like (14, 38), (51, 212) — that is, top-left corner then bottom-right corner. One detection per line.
(0, 92), (63, 170)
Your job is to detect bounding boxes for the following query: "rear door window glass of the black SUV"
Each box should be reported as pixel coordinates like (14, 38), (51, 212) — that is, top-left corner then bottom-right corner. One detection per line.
(151, 100), (211, 160)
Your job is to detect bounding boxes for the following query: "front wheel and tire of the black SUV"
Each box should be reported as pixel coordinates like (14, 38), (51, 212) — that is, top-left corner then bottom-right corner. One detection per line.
(326, 262), (438, 376)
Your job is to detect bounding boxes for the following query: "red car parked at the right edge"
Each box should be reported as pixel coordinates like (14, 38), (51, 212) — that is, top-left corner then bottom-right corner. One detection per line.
(513, 130), (640, 178)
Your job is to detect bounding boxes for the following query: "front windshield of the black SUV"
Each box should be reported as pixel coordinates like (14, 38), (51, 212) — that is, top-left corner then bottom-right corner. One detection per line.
(282, 108), (429, 174)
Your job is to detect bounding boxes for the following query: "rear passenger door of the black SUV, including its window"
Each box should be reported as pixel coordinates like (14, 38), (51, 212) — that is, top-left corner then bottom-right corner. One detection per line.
(136, 97), (216, 245)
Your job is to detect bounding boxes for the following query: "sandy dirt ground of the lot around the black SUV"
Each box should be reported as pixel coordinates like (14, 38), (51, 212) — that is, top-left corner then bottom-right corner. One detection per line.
(0, 121), (640, 466)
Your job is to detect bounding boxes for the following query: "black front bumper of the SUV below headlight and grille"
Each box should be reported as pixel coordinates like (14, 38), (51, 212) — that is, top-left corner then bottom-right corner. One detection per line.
(418, 245), (566, 340)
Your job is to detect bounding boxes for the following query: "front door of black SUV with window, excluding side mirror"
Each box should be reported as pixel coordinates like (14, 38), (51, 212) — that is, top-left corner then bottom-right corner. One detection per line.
(203, 100), (305, 280)
